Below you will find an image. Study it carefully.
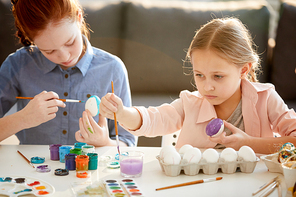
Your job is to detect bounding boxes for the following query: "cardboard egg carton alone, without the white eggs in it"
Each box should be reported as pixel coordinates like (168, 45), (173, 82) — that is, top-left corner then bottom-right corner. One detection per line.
(156, 155), (260, 176)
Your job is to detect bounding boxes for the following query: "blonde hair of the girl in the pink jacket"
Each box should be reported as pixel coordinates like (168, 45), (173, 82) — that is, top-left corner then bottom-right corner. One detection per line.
(186, 18), (260, 82)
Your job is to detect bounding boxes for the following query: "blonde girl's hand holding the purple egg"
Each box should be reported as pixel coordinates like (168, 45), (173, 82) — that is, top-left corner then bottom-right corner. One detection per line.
(209, 121), (250, 150)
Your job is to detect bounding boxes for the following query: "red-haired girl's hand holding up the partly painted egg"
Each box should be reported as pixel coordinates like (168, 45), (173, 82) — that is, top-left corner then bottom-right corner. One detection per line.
(75, 110), (111, 146)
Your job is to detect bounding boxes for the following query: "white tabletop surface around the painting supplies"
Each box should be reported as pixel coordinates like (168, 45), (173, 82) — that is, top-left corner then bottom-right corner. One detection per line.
(0, 145), (286, 197)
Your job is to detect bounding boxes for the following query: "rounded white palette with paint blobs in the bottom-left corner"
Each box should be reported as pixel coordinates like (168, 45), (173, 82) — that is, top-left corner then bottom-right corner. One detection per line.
(0, 176), (55, 197)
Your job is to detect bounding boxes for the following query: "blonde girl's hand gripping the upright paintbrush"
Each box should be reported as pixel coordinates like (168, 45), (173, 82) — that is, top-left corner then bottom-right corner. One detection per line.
(100, 93), (123, 120)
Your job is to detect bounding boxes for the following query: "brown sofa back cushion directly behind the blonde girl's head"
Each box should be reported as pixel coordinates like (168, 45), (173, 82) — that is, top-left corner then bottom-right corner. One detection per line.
(122, 1), (270, 94)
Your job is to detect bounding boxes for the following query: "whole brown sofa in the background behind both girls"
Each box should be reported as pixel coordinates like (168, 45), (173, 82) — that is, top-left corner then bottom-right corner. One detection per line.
(0, 0), (296, 146)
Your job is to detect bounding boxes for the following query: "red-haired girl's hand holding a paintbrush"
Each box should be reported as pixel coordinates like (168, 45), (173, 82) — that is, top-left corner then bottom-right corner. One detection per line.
(20, 91), (66, 128)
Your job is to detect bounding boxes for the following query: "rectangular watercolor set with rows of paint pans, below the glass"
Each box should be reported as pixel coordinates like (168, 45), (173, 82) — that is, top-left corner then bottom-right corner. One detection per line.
(104, 179), (144, 197)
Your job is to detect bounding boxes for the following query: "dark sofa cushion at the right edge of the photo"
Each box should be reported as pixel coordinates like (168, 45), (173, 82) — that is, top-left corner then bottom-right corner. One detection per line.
(271, 1), (296, 100)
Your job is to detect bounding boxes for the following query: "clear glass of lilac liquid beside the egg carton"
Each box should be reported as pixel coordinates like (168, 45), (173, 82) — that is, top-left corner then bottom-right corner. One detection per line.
(119, 151), (144, 178)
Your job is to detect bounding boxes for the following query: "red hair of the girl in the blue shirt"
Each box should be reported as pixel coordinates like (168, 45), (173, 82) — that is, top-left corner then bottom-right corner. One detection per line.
(11, 0), (89, 46)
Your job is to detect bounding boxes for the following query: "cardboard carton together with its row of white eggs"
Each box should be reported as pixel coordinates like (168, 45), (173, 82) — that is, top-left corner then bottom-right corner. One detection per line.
(156, 145), (259, 176)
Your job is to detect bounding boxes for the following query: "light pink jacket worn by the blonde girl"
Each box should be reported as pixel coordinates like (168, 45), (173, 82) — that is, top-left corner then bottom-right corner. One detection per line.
(124, 80), (296, 148)
